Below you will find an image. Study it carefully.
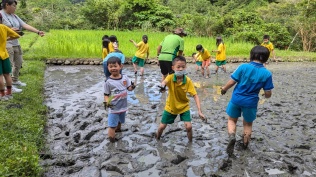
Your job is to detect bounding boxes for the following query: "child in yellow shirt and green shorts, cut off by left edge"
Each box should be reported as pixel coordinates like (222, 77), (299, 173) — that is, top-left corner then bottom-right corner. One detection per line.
(0, 14), (20, 101)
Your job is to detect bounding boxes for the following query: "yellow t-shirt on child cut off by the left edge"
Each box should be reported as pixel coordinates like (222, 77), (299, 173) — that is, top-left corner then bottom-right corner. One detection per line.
(0, 24), (19, 60)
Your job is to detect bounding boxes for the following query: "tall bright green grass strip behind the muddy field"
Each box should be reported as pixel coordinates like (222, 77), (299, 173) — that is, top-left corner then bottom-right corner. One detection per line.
(21, 30), (316, 60)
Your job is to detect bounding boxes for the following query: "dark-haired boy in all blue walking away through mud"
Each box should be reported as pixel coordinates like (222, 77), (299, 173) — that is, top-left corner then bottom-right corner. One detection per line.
(221, 46), (274, 156)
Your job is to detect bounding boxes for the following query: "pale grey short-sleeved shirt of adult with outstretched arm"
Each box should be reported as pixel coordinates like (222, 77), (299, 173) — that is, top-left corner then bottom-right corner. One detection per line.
(0, 10), (26, 47)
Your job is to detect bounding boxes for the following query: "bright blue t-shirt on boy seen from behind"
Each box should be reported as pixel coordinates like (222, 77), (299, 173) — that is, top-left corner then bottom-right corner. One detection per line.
(231, 62), (274, 108)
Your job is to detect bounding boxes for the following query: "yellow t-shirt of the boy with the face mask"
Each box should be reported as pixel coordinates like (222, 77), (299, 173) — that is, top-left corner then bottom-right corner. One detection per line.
(165, 74), (197, 115)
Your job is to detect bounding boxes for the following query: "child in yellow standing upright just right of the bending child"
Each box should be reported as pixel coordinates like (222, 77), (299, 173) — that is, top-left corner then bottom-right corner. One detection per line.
(212, 37), (226, 74)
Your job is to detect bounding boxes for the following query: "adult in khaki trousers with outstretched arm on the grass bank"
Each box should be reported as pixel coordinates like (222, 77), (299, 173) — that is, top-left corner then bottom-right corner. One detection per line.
(0, 0), (45, 90)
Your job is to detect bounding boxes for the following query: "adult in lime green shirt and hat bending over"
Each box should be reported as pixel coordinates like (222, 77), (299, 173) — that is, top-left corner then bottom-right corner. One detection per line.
(157, 28), (187, 81)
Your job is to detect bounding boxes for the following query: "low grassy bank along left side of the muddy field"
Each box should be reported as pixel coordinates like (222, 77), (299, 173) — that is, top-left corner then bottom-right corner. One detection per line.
(0, 61), (47, 176)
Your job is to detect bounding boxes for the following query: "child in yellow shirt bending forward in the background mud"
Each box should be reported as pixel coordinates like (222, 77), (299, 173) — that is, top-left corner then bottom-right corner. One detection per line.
(196, 44), (211, 78)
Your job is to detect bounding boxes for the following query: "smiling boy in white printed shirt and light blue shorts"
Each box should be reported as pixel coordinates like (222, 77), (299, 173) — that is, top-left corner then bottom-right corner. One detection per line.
(104, 57), (136, 143)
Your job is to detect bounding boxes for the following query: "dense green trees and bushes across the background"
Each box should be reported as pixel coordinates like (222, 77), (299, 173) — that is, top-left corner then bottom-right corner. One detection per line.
(17, 0), (316, 51)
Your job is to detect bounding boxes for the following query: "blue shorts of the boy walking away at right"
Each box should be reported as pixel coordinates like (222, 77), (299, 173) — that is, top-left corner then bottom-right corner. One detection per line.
(226, 102), (257, 123)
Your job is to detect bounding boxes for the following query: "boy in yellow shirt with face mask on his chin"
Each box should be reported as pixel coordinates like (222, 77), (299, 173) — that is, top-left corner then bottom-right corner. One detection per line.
(156, 56), (205, 142)
